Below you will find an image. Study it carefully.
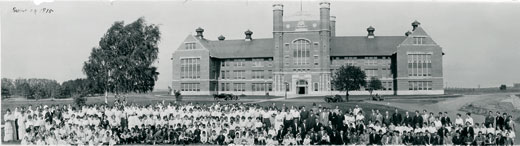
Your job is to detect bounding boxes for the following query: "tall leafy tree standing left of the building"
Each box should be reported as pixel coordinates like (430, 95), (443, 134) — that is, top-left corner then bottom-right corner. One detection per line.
(83, 17), (161, 99)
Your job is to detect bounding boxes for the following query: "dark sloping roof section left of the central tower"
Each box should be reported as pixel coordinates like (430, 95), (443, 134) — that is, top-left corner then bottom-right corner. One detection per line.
(201, 38), (274, 58)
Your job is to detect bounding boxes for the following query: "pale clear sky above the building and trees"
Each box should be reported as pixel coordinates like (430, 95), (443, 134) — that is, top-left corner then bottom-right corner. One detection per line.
(0, 0), (520, 89)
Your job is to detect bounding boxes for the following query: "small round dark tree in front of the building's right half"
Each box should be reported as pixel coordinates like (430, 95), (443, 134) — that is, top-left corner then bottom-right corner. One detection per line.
(332, 66), (367, 102)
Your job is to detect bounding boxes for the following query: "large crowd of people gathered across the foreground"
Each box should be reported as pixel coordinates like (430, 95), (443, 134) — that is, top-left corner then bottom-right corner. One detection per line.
(3, 100), (516, 145)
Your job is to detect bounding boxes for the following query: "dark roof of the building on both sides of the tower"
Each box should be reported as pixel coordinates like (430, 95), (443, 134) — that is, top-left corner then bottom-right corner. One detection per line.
(196, 36), (406, 58)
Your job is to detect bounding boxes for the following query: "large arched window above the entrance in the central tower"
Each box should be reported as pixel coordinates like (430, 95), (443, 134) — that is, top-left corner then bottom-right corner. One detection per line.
(292, 39), (311, 65)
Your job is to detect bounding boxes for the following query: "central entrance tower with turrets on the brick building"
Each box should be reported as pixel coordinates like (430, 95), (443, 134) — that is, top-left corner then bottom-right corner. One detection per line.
(273, 2), (335, 94)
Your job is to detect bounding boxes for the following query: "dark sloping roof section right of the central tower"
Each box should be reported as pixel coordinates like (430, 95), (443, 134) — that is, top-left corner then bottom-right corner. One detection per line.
(330, 36), (406, 56)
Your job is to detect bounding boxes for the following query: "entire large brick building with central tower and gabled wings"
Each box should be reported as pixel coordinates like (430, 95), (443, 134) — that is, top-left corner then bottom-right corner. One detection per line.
(172, 2), (444, 95)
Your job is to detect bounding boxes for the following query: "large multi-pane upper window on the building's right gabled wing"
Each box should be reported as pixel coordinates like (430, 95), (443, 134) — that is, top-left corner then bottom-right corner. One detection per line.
(408, 54), (432, 76)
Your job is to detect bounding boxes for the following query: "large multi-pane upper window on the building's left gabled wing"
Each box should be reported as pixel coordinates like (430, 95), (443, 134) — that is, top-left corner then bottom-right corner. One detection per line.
(181, 58), (200, 79)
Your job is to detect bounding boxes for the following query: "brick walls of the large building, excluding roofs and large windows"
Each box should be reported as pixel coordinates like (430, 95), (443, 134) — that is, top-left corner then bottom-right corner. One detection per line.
(172, 3), (444, 95)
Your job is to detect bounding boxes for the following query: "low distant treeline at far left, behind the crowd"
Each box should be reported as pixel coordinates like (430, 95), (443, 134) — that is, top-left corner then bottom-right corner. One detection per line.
(2, 78), (103, 99)
